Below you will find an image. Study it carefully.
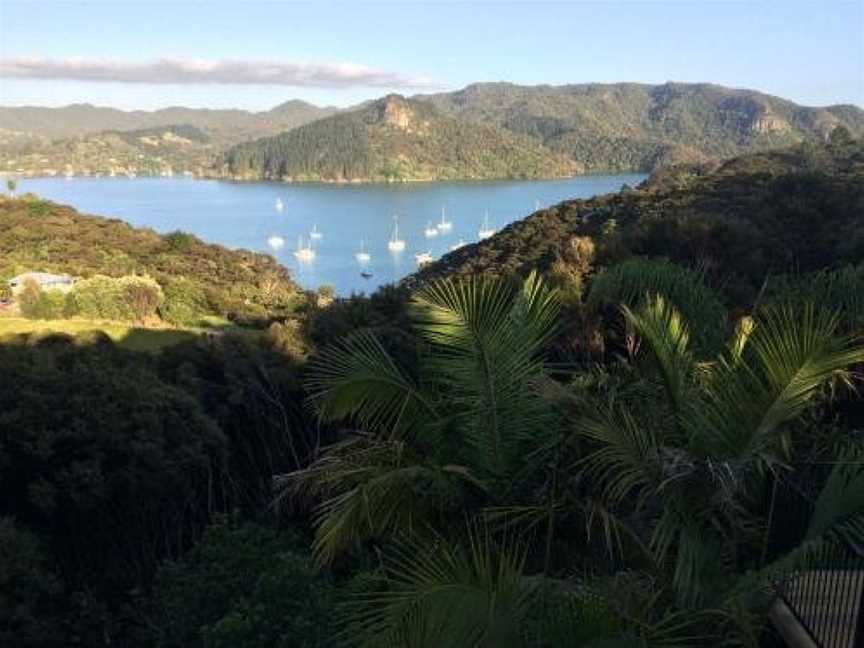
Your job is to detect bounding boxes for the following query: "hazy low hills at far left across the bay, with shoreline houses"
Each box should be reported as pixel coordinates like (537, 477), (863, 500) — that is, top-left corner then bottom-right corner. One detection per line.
(0, 101), (335, 175)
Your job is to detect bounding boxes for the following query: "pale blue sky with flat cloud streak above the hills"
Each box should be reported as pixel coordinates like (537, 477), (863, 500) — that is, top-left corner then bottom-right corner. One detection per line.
(0, 0), (864, 110)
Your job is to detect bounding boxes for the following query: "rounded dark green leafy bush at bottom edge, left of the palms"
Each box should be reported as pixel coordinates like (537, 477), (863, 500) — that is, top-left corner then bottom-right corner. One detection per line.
(150, 519), (334, 648)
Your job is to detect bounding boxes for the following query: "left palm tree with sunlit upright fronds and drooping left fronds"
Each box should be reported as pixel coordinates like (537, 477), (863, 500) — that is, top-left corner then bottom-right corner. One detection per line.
(282, 274), (558, 563)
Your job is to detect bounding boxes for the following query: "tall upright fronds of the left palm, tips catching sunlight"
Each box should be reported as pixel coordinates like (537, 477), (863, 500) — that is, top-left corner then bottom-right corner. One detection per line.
(412, 275), (558, 484)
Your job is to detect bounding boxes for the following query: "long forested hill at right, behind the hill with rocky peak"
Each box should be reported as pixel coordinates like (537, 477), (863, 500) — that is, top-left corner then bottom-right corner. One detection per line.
(423, 83), (864, 171)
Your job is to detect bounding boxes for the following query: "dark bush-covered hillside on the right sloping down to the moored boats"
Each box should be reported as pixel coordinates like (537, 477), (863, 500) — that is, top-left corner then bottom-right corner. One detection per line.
(406, 131), (864, 303)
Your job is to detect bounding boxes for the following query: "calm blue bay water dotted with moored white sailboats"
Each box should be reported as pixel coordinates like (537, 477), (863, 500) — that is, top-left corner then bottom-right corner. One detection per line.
(19, 174), (645, 295)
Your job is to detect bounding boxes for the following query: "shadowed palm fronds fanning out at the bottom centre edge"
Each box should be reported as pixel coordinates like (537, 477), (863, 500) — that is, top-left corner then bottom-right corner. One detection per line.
(344, 525), (538, 648)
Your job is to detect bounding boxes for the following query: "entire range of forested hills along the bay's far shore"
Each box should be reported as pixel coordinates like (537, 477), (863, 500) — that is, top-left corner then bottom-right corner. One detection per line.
(0, 83), (864, 182)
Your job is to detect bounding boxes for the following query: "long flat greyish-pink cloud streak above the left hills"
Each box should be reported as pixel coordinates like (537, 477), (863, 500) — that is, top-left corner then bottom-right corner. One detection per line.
(0, 58), (437, 88)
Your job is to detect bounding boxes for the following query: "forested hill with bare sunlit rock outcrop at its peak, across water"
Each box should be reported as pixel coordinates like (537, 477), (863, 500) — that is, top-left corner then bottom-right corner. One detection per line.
(221, 95), (583, 181)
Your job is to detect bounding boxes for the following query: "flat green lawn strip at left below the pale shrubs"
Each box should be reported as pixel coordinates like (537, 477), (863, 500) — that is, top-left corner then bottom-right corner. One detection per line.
(0, 317), (201, 352)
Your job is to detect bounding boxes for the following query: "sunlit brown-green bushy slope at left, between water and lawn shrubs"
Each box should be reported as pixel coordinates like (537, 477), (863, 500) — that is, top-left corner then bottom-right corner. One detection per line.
(0, 196), (303, 321)
